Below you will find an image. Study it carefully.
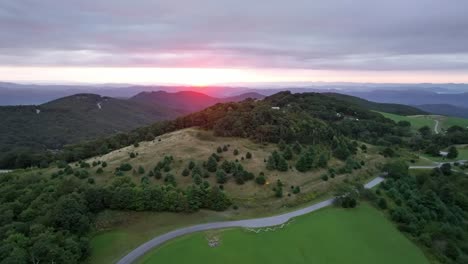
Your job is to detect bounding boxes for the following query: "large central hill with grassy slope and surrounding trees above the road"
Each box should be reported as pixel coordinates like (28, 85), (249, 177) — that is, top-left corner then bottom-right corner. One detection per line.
(0, 92), (468, 263)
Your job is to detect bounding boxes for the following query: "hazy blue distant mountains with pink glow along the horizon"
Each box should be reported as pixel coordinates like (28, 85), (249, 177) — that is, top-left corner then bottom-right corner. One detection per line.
(0, 82), (468, 118)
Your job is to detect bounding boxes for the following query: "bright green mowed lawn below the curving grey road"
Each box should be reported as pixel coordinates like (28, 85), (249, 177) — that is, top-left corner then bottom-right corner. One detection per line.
(139, 204), (429, 264)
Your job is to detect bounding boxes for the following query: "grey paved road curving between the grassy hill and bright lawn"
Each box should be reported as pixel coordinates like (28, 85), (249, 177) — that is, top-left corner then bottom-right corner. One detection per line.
(117, 177), (384, 264)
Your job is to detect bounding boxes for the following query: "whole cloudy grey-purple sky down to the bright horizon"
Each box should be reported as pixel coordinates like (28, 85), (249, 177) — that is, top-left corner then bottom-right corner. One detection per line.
(0, 0), (468, 85)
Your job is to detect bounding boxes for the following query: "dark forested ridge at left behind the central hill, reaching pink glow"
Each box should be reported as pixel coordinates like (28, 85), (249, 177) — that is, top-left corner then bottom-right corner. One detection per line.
(0, 92), (260, 168)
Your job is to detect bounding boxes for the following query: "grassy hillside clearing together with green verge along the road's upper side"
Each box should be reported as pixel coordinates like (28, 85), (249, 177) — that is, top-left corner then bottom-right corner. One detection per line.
(51, 128), (385, 264)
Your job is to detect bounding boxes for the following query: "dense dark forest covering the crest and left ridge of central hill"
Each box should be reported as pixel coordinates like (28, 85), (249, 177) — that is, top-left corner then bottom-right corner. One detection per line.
(0, 92), (428, 168)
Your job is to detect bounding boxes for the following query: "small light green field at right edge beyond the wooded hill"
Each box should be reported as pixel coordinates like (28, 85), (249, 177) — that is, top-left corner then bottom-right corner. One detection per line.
(379, 112), (468, 132)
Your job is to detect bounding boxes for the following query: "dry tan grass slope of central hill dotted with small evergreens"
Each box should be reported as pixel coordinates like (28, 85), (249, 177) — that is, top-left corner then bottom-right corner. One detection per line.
(81, 128), (382, 206)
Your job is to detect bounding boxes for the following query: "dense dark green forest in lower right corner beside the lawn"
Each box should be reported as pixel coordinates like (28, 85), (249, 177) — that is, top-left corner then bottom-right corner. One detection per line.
(373, 162), (468, 264)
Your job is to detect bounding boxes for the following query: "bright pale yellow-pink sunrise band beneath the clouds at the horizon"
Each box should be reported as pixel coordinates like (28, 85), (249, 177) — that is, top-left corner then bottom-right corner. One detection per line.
(0, 67), (468, 86)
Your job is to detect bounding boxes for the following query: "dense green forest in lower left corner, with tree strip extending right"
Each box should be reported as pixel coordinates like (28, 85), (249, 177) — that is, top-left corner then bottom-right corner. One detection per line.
(0, 168), (231, 264)
